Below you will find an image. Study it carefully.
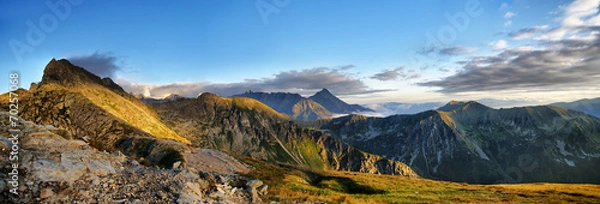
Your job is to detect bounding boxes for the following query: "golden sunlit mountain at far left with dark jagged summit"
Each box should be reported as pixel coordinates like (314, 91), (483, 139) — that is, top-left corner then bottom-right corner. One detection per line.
(0, 59), (189, 167)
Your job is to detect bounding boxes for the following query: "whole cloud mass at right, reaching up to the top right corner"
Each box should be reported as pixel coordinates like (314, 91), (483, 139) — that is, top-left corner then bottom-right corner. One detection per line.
(419, 0), (600, 94)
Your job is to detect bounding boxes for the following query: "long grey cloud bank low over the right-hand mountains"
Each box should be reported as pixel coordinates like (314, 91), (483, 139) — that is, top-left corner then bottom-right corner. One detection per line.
(419, 38), (600, 93)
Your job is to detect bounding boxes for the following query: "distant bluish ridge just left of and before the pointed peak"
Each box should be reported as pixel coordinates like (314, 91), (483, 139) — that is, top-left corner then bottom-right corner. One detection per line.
(236, 91), (333, 120)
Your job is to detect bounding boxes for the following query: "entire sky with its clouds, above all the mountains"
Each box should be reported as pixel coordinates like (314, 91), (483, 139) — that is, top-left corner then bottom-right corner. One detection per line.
(0, 0), (600, 106)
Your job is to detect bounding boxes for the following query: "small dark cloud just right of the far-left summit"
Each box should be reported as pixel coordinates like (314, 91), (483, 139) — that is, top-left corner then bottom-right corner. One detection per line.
(67, 51), (121, 77)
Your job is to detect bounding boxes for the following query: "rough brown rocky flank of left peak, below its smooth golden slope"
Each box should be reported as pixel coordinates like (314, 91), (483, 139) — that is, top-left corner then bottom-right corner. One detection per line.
(0, 84), (151, 151)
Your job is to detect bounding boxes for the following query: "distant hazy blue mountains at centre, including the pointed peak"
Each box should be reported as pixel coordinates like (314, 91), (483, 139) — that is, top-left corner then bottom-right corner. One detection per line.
(235, 89), (373, 120)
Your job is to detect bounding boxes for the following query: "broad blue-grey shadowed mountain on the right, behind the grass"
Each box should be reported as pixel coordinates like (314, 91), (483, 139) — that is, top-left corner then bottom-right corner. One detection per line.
(323, 101), (600, 183)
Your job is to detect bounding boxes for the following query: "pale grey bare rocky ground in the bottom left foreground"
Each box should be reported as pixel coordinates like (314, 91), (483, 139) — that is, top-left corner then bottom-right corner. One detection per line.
(0, 112), (268, 203)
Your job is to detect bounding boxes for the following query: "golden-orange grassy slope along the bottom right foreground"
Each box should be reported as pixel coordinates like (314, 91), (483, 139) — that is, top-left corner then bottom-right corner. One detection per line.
(241, 157), (600, 203)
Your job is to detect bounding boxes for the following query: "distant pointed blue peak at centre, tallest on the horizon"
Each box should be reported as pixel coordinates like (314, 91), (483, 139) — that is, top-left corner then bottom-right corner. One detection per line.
(308, 89), (373, 114)
